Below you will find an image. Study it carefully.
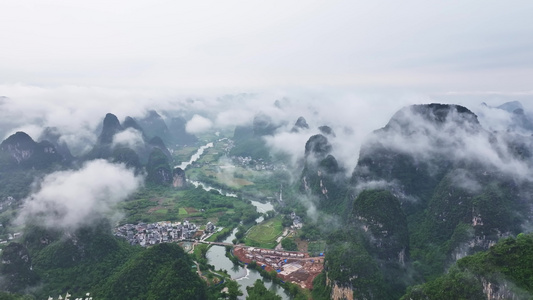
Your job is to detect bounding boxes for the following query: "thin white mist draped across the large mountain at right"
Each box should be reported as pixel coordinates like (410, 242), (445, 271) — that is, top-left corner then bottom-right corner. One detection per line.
(368, 103), (533, 180)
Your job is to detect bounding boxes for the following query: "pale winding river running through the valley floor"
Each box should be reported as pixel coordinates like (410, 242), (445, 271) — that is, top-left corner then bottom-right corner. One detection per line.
(178, 143), (290, 300)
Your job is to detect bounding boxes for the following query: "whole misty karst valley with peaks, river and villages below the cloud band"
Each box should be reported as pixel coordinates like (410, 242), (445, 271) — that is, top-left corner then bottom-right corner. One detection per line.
(0, 103), (533, 300)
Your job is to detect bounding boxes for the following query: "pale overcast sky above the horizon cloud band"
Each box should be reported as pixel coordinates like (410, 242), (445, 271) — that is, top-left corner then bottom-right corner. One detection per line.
(0, 0), (533, 92)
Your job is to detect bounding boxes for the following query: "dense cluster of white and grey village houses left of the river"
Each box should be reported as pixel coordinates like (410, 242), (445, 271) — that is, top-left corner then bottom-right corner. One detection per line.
(115, 220), (216, 247)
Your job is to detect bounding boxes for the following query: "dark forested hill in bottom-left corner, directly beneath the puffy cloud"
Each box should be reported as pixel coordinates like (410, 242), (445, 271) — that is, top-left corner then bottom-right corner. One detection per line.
(1, 220), (141, 299)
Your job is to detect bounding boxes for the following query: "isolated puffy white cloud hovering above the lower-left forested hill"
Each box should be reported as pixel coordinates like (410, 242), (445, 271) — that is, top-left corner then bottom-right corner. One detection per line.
(17, 160), (142, 230)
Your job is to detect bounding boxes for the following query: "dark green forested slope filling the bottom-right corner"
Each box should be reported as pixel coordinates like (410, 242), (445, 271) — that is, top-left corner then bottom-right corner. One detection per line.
(402, 234), (533, 300)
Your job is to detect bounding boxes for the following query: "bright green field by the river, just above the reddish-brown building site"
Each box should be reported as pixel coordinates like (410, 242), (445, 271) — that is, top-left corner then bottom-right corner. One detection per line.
(245, 217), (283, 248)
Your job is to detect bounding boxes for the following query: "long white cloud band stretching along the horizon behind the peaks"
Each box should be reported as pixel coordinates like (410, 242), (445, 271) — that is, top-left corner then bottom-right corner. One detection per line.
(0, 84), (533, 175)
